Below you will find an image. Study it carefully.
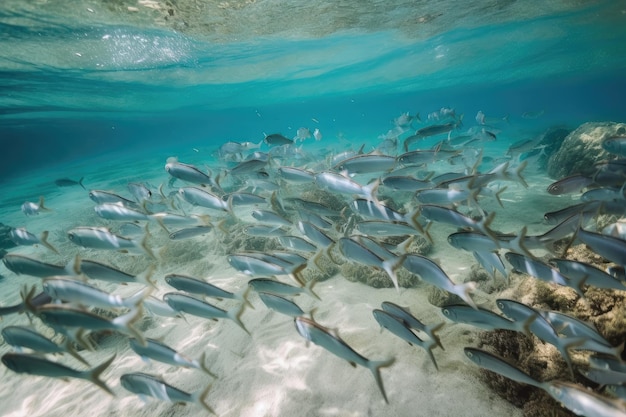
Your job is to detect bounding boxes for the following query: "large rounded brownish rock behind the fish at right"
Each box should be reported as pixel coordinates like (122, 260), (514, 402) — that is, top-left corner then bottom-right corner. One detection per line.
(548, 122), (626, 179)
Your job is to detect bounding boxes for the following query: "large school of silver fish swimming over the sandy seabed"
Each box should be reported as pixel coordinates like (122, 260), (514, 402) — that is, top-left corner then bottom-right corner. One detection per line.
(0, 108), (626, 417)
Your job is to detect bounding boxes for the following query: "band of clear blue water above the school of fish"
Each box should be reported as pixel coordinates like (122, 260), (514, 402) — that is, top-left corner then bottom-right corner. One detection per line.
(0, 1), (626, 179)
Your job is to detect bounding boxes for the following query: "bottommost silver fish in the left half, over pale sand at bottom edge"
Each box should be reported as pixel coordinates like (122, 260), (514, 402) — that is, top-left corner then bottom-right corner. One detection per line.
(120, 372), (216, 414)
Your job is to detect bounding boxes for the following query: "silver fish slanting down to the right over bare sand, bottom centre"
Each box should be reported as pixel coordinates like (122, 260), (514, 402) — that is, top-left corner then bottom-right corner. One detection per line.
(294, 317), (395, 404)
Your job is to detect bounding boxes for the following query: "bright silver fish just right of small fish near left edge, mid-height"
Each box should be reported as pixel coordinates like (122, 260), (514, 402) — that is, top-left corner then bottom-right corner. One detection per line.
(67, 227), (156, 259)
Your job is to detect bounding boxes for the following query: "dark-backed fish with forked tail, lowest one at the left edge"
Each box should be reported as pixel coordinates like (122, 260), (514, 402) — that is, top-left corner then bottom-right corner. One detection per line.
(2, 353), (115, 396)
